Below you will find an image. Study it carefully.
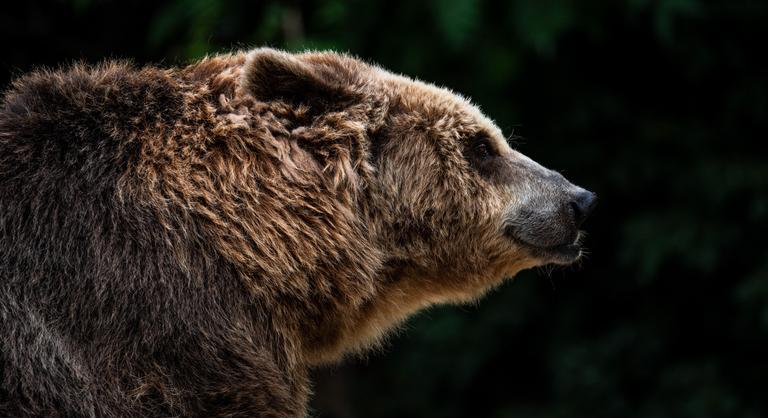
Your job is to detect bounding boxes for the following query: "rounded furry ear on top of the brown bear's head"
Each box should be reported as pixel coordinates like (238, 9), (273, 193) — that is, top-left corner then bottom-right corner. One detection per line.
(241, 48), (351, 103)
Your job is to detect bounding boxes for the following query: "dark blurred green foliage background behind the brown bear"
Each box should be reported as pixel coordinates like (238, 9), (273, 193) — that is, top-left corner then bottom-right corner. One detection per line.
(0, 0), (768, 418)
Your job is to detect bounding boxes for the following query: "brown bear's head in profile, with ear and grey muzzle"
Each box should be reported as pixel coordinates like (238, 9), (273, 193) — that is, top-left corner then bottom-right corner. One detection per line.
(240, 49), (596, 361)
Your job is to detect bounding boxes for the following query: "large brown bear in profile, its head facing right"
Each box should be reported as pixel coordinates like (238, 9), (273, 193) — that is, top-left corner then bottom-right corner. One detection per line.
(0, 49), (595, 417)
